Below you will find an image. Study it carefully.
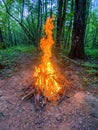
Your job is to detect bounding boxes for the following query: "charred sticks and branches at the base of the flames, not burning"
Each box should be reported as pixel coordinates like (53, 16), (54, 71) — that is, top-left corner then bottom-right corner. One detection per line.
(21, 79), (70, 110)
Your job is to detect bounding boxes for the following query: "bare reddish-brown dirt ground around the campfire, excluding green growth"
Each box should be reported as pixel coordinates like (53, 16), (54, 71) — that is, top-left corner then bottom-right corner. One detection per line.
(0, 55), (98, 130)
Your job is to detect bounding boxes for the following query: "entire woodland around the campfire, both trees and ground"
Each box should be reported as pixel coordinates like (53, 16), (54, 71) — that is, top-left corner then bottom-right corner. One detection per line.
(0, 0), (98, 130)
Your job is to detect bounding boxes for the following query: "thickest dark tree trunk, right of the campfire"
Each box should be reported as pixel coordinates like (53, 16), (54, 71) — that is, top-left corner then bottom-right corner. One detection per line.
(69, 0), (87, 59)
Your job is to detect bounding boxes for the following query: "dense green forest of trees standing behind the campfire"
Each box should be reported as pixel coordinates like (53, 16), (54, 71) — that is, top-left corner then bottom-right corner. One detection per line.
(0, 0), (98, 59)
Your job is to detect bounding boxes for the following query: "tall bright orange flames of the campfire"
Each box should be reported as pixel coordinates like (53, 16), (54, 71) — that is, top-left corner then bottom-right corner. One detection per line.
(33, 17), (68, 100)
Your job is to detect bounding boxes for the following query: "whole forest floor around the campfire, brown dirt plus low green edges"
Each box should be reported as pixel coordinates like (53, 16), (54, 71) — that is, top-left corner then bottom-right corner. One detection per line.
(0, 49), (98, 130)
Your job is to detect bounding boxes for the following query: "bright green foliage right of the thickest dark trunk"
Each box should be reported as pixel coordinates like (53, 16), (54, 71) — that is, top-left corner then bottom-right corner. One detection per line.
(85, 7), (98, 50)
